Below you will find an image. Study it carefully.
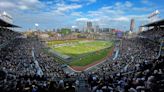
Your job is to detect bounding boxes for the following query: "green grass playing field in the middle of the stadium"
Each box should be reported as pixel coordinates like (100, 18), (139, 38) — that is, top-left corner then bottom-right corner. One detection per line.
(48, 40), (113, 66)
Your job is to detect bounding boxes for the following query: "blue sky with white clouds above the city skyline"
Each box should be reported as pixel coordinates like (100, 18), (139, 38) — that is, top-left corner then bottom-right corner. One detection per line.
(0, 0), (164, 30)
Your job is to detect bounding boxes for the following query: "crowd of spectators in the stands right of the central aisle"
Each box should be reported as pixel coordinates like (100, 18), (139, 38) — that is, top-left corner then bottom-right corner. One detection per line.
(88, 31), (164, 92)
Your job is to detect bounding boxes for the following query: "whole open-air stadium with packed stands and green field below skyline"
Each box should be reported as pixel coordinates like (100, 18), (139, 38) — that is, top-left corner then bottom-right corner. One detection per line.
(0, 0), (164, 92)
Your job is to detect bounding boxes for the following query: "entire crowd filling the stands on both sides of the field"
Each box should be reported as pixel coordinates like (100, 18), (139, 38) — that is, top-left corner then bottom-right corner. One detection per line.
(0, 26), (164, 92)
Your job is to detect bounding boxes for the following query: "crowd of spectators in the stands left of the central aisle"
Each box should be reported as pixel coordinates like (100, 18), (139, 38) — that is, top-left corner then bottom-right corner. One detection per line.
(0, 30), (80, 92)
